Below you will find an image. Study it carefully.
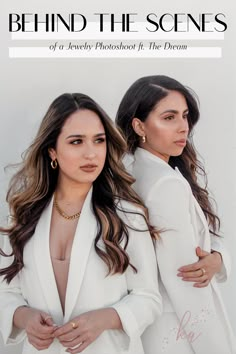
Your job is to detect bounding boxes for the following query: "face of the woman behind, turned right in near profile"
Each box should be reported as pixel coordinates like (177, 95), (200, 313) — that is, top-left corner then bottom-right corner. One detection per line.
(133, 91), (189, 162)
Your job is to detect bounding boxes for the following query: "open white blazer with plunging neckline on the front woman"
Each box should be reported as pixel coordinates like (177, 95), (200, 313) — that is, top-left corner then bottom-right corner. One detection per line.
(0, 189), (161, 354)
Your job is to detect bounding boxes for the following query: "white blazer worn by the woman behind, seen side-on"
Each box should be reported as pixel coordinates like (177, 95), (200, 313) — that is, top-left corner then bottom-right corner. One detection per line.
(132, 148), (236, 354)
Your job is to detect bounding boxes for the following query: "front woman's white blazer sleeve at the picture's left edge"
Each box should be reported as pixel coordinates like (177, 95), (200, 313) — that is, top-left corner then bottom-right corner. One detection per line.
(0, 236), (27, 345)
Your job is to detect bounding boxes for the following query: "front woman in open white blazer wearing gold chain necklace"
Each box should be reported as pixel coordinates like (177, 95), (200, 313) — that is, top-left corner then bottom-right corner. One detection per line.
(0, 94), (161, 354)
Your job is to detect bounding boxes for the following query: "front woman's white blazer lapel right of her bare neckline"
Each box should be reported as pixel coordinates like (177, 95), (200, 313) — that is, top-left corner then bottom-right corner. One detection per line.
(64, 188), (97, 322)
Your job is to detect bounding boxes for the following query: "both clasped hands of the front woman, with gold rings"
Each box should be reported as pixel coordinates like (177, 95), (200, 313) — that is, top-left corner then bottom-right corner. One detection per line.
(21, 307), (121, 354)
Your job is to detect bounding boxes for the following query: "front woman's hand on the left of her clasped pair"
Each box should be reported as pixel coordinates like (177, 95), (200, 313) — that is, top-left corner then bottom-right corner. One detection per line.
(14, 306), (55, 350)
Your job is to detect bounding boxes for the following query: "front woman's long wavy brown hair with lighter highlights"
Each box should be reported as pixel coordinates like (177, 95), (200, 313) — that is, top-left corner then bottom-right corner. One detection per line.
(0, 93), (155, 283)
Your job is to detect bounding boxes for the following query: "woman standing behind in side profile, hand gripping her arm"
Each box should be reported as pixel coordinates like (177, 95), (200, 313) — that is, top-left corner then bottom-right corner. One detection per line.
(116, 75), (236, 354)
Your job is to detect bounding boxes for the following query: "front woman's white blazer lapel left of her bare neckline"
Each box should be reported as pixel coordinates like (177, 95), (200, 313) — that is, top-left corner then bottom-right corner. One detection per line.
(33, 198), (63, 323)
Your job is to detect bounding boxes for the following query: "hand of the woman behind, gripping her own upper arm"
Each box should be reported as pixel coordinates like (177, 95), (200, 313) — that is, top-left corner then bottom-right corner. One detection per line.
(177, 247), (222, 288)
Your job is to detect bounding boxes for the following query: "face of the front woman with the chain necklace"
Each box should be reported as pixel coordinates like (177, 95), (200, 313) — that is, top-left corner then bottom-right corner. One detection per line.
(49, 109), (106, 185)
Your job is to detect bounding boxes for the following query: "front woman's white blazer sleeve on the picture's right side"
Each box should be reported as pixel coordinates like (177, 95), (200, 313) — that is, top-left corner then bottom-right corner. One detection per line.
(112, 210), (162, 343)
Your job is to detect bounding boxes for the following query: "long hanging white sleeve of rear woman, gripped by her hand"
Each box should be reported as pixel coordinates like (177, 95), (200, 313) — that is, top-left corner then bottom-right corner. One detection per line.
(146, 176), (230, 354)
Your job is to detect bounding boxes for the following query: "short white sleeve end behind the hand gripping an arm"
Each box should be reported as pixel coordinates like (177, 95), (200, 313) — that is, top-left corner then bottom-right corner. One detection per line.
(211, 235), (231, 282)
